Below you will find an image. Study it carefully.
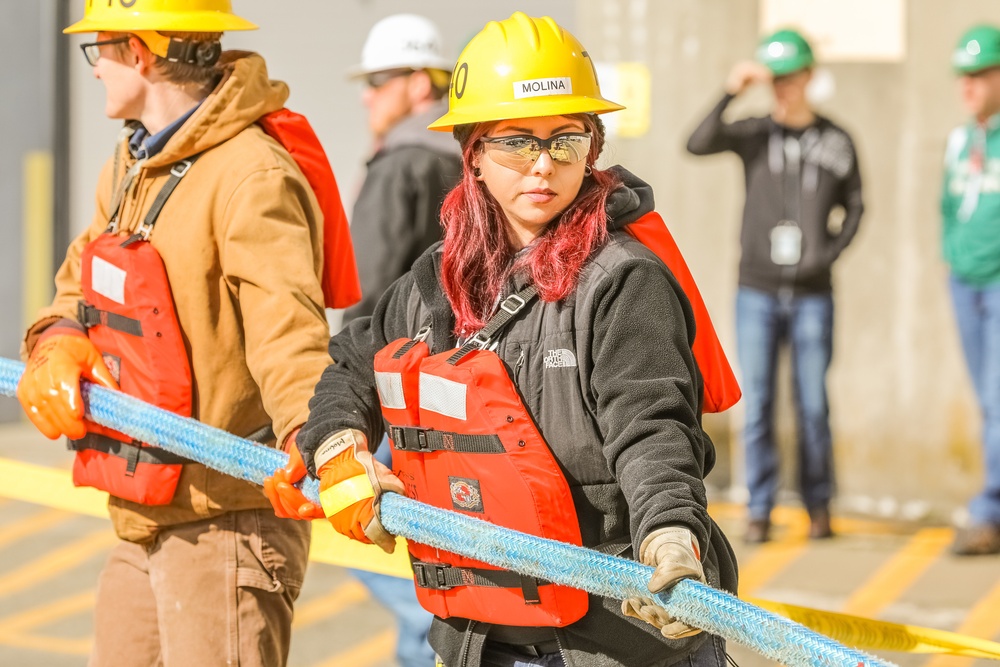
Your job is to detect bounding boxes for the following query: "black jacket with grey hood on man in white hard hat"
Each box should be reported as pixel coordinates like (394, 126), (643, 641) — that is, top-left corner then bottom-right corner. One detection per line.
(344, 103), (462, 322)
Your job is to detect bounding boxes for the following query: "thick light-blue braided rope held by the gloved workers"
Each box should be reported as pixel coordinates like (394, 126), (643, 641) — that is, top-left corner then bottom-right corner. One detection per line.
(0, 358), (892, 667)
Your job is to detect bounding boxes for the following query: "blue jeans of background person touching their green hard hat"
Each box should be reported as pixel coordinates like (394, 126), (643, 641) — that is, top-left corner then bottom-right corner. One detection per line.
(736, 287), (833, 519)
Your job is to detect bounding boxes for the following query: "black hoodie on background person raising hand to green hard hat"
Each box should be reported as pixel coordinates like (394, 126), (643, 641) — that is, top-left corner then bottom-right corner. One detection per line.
(687, 95), (864, 294)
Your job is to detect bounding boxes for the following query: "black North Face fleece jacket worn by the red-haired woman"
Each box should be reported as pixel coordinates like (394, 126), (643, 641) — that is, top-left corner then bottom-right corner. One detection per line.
(298, 170), (736, 667)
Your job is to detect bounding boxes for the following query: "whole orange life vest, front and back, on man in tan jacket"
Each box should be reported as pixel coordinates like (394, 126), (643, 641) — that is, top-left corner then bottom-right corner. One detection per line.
(70, 109), (361, 505)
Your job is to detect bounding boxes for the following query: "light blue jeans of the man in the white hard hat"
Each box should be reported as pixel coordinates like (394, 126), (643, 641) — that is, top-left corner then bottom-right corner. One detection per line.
(351, 438), (434, 667)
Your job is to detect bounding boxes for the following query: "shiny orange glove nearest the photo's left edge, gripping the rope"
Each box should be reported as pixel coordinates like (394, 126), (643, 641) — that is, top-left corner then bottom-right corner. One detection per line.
(17, 326), (118, 440)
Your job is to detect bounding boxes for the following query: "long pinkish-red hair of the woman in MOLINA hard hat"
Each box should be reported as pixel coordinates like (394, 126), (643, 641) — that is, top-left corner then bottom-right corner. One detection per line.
(441, 114), (621, 335)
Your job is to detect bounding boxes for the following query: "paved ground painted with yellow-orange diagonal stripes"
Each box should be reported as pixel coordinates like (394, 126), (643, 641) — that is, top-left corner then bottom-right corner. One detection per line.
(0, 425), (1000, 667)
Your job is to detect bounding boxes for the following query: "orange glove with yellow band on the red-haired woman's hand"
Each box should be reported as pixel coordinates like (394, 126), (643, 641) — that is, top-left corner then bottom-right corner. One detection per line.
(314, 429), (405, 553)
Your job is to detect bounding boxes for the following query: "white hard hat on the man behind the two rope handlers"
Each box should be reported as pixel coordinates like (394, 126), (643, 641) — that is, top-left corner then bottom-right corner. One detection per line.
(351, 14), (455, 77)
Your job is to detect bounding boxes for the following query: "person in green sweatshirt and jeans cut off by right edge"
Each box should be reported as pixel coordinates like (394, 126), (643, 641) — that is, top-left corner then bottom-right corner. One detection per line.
(941, 25), (1000, 556)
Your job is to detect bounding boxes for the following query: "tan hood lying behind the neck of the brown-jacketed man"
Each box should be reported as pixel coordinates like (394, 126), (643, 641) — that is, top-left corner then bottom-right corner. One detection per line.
(146, 51), (288, 167)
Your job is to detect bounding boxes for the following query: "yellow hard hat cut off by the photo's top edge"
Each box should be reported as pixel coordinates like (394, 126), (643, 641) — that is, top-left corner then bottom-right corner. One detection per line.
(63, 0), (257, 33)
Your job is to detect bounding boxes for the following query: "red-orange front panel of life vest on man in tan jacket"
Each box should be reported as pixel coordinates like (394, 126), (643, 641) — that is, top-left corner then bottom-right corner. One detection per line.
(72, 233), (191, 505)
